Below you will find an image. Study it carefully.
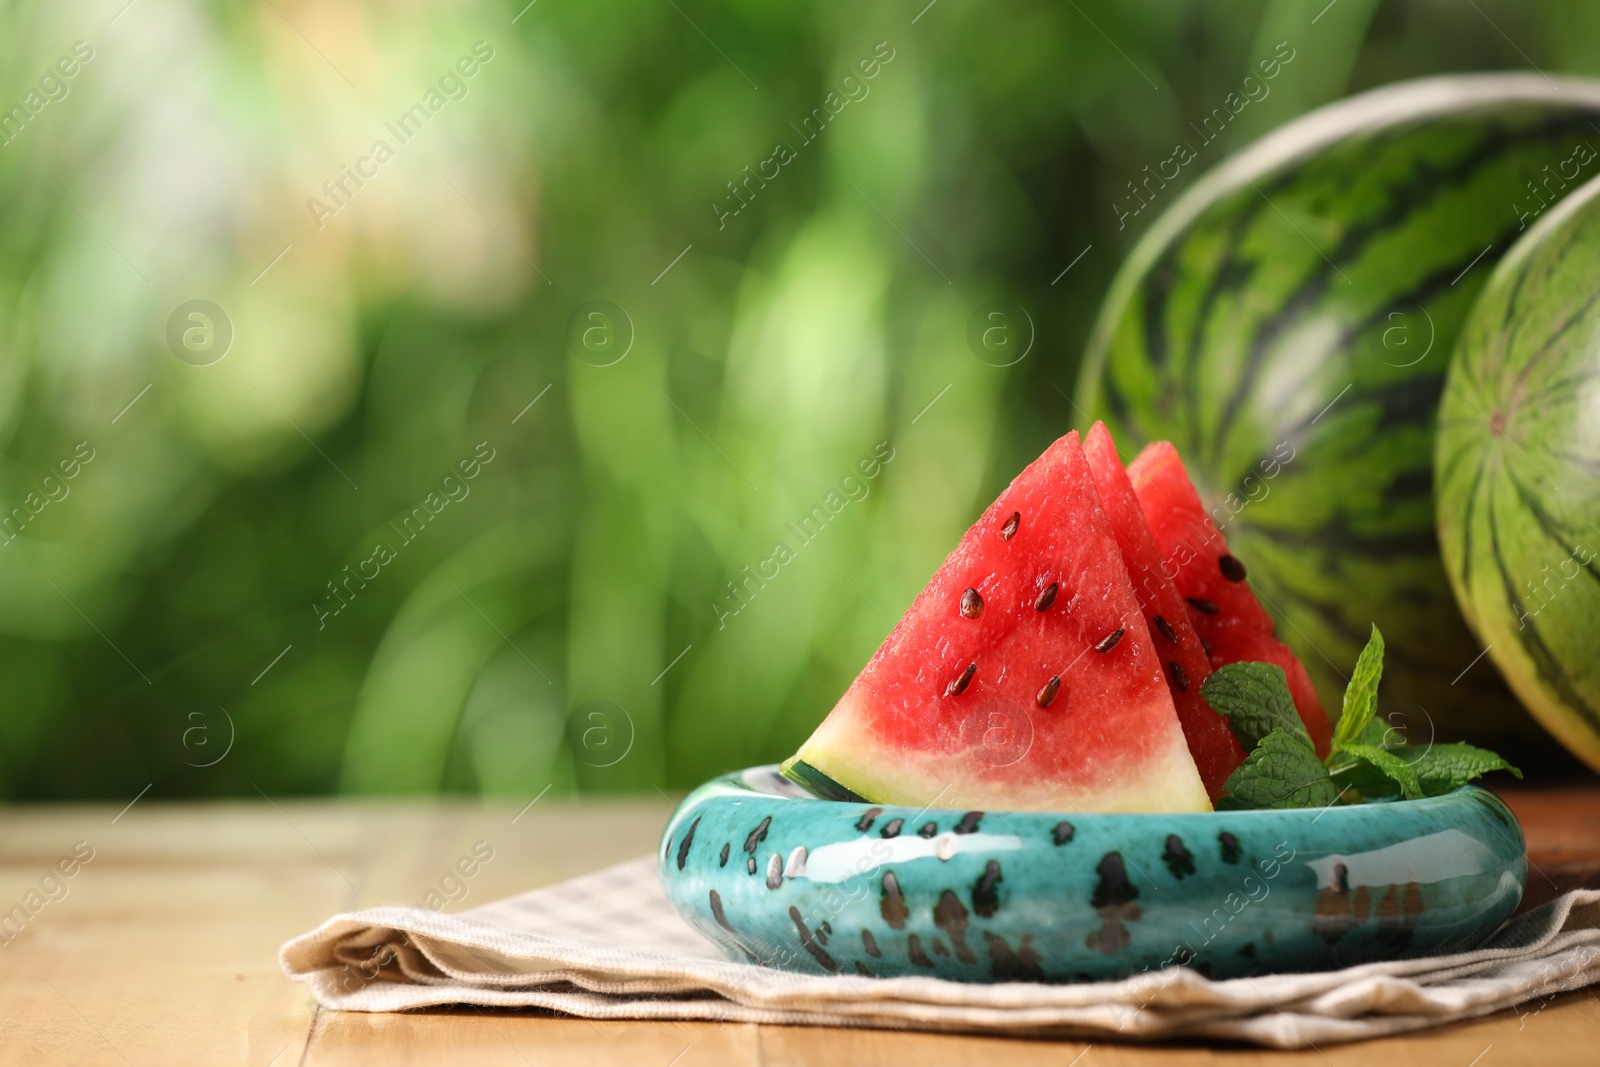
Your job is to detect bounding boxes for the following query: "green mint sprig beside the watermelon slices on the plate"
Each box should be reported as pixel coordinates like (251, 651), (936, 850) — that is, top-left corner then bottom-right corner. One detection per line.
(1200, 625), (1522, 809)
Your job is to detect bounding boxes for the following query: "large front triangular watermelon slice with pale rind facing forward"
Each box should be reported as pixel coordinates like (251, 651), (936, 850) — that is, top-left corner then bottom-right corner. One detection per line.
(786, 432), (1211, 811)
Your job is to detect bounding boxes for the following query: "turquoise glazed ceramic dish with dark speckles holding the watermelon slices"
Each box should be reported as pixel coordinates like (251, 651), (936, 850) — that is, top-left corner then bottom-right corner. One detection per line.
(659, 766), (1528, 982)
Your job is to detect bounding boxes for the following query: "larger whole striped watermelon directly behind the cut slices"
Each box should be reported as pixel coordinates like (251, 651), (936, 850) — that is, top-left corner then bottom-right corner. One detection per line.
(1078, 75), (1600, 747)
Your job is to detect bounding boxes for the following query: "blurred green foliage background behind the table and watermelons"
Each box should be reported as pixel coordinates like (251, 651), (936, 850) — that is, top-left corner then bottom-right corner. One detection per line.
(0, 0), (1600, 798)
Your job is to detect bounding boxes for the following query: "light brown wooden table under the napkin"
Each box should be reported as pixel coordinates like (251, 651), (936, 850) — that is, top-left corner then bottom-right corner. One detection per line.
(0, 790), (1600, 1067)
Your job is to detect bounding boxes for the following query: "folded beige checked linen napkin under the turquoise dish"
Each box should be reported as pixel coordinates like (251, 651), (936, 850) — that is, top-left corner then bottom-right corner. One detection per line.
(280, 856), (1600, 1048)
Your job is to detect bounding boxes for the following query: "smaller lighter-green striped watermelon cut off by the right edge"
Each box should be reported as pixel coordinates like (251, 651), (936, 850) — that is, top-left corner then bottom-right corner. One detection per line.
(1435, 171), (1600, 769)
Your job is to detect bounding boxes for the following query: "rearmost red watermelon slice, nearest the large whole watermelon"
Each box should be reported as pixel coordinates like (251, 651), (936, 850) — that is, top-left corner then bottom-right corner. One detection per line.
(1128, 442), (1333, 755)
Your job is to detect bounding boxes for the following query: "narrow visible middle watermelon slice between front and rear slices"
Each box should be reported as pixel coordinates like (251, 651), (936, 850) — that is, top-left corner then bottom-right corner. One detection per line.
(1083, 422), (1245, 800)
